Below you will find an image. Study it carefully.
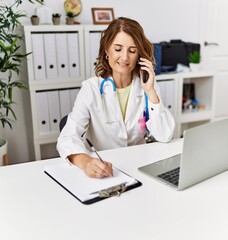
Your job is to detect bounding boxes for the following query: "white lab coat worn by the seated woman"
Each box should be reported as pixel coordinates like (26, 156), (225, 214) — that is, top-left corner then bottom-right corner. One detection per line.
(57, 77), (175, 158)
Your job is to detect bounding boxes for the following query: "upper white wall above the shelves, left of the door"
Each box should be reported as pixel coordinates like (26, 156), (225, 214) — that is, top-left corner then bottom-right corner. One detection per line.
(19, 0), (200, 42)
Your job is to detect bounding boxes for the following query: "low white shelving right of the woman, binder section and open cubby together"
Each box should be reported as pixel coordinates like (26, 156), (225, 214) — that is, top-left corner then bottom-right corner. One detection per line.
(156, 71), (215, 138)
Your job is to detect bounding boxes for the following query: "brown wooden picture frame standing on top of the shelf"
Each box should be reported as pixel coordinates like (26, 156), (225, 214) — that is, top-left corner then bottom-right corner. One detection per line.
(91, 8), (114, 24)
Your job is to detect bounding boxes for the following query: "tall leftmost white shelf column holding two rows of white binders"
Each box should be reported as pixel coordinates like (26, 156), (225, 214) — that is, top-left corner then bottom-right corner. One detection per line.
(24, 25), (85, 160)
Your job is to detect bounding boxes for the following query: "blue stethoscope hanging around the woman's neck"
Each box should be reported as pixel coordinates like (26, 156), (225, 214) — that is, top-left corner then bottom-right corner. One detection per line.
(100, 78), (153, 143)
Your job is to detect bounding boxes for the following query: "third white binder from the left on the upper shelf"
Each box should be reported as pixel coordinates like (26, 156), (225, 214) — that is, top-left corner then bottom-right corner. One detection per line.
(55, 33), (69, 78)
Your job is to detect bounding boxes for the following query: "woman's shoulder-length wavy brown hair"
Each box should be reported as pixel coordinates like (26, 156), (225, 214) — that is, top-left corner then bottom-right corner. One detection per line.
(95, 17), (155, 78)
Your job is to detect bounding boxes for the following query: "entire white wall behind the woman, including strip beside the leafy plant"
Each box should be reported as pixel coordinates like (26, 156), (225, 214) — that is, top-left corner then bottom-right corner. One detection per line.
(0, 0), (200, 163)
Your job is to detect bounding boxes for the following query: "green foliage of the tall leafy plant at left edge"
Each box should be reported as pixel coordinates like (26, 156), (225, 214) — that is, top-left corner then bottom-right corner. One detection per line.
(0, 0), (41, 128)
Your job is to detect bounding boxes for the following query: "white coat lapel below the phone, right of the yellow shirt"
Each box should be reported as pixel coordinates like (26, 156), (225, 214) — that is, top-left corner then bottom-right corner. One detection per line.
(125, 77), (144, 123)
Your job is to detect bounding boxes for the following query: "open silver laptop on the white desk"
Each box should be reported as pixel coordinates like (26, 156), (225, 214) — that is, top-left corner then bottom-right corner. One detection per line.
(139, 118), (228, 190)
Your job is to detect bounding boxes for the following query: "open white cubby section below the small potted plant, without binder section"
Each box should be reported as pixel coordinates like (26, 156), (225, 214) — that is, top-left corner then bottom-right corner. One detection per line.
(176, 71), (215, 137)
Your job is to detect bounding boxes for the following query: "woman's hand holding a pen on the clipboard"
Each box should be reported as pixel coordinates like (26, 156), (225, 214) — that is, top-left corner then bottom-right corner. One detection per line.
(68, 153), (113, 178)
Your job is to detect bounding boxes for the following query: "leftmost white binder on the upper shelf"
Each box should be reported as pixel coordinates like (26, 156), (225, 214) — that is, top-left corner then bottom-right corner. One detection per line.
(31, 33), (46, 80)
